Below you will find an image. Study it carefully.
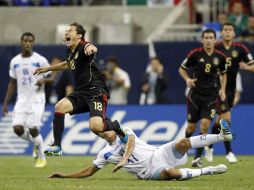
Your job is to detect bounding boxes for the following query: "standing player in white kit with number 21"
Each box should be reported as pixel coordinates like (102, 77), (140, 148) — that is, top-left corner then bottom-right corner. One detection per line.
(2, 32), (53, 168)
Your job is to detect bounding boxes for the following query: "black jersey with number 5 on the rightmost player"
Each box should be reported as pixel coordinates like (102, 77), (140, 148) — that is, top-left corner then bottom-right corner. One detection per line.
(215, 43), (253, 92)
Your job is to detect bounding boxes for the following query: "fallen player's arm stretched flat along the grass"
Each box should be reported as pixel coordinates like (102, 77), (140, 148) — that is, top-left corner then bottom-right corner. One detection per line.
(49, 165), (100, 178)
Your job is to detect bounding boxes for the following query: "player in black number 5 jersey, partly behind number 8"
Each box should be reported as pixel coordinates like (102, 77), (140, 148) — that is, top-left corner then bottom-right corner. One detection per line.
(205, 23), (254, 163)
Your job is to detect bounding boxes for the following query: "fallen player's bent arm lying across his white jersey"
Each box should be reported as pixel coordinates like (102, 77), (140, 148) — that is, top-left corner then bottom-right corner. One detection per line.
(113, 135), (135, 172)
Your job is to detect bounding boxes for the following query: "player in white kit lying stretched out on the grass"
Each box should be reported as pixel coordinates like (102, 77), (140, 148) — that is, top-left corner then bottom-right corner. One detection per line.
(50, 120), (233, 180)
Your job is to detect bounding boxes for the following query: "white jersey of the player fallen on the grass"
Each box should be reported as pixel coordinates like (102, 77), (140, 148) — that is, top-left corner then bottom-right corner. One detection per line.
(93, 128), (157, 178)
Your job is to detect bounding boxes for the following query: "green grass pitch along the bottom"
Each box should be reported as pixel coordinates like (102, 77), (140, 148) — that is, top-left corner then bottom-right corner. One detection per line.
(0, 156), (254, 190)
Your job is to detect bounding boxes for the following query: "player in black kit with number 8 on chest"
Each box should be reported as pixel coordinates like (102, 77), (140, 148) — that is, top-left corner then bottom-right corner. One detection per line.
(179, 29), (227, 167)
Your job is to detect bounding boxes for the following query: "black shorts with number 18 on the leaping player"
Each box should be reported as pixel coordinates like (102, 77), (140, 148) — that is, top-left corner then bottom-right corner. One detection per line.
(66, 88), (108, 119)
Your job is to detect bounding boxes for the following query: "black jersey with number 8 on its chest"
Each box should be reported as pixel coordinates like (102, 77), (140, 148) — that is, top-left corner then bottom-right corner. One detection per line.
(181, 48), (226, 96)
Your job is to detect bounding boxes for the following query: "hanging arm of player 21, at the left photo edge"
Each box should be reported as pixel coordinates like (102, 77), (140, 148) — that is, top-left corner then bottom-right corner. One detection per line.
(2, 78), (17, 116)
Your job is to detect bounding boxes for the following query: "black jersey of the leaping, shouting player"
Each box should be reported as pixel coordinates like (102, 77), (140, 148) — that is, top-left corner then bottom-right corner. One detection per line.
(67, 42), (109, 96)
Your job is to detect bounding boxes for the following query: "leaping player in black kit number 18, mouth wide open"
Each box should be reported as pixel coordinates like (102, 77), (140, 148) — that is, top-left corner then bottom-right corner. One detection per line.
(34, 23), (124, 155)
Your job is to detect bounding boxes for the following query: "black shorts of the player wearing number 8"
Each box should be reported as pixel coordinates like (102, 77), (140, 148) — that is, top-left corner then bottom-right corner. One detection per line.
(187, 89), (217, 123)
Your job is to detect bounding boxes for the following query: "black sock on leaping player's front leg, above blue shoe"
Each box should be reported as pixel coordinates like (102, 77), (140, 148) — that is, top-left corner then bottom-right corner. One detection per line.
(53, 112), (64, 147)
